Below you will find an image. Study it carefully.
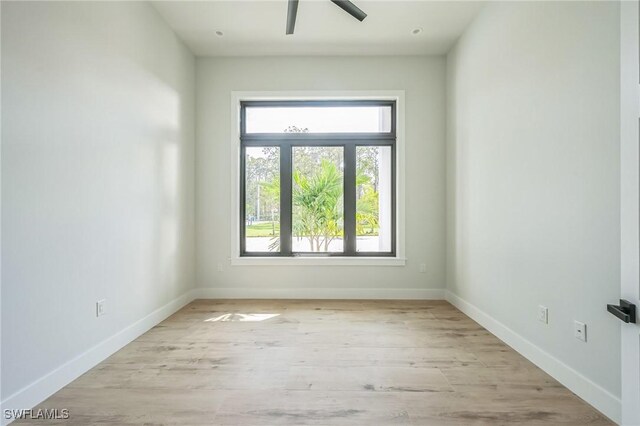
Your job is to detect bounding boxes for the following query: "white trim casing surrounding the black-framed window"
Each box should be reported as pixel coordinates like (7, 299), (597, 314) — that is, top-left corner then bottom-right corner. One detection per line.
(230, 91), (405, 266)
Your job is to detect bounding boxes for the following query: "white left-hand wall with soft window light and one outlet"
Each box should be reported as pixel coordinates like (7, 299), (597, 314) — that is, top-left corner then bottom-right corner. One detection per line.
(1, 2), (195, 402)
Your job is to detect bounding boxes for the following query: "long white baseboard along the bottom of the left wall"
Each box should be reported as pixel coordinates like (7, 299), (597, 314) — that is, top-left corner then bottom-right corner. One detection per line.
(0, 291), (193, 425)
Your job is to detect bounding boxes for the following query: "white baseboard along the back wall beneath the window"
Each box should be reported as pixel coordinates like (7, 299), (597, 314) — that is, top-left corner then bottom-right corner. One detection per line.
(193, 287), (445, 300)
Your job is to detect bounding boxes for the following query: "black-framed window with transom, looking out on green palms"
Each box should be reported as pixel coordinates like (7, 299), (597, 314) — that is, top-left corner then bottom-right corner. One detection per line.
(239, 100), (396, 257)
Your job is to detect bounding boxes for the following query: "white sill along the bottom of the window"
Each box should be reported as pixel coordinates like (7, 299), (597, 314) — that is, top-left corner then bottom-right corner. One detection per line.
(231, 256), (406, 266)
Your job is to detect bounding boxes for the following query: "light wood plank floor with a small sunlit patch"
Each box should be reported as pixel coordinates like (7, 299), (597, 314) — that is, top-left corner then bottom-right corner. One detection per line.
(26, 300), (611, 426)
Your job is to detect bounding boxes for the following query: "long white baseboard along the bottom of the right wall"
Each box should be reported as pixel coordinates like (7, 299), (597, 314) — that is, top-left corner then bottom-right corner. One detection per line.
(446, 291), (622, 424)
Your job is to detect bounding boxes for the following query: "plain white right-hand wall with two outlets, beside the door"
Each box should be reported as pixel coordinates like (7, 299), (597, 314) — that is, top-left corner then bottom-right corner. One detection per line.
(447, 2), (620, 418)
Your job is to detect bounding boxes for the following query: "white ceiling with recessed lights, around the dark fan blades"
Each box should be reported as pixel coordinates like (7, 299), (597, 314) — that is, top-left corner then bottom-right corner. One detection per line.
(152, 0), (483, 56)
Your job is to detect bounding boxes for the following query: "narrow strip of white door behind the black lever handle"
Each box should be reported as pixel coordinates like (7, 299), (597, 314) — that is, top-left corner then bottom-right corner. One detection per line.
(620, 0), (640, 426)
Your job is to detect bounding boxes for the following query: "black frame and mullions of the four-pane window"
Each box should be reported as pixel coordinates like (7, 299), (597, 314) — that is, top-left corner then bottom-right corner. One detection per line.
(239, 100), (397, 258)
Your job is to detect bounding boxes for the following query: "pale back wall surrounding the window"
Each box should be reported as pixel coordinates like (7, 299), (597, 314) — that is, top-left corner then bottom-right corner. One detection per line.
(196, 57), (445, 297)
